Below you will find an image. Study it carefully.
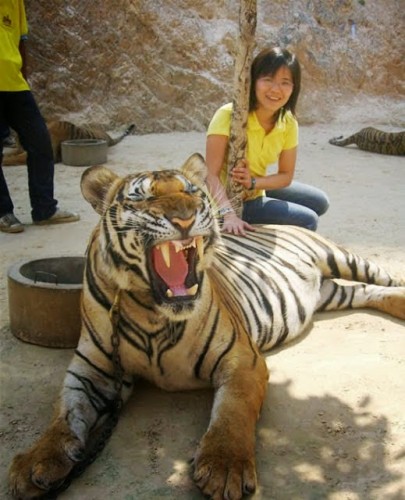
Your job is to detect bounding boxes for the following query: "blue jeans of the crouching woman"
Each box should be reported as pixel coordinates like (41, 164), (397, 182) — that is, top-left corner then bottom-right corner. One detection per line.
(242, 181), (329, 231)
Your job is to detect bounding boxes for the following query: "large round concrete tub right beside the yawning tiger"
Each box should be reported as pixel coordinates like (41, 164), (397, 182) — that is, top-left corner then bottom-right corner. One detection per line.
(7, 257), (85, 347)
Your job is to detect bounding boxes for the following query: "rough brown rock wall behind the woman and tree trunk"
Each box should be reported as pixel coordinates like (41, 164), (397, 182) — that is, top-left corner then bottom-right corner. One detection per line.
(25, 0), (405, 134)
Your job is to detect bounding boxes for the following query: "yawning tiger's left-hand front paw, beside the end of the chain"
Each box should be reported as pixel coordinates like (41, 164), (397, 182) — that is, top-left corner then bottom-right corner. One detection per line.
(9, 423), (83, 500)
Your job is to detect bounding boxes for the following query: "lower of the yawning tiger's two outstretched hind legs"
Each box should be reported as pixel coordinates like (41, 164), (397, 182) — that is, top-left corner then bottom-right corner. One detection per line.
(316, 279), (405, 319)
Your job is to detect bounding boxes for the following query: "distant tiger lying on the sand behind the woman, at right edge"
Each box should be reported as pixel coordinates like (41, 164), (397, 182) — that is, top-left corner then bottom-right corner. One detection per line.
(329, 127), (405, 156)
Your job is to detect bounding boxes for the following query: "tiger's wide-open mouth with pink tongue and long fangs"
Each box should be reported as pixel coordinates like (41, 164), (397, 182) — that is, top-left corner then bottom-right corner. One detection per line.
(151, 236), (204, 301)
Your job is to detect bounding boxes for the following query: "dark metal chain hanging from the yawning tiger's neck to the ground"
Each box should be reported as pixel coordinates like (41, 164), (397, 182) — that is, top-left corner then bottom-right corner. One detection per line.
(40, 290), (124, 500)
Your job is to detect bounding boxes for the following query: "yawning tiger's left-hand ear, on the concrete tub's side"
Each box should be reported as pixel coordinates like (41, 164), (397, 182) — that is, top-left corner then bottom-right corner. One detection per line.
(80, 165), (121, 215)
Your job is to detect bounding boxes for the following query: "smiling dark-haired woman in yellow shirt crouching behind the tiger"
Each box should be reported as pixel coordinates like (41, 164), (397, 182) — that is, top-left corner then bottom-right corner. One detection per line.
(206, 47), (329, 235)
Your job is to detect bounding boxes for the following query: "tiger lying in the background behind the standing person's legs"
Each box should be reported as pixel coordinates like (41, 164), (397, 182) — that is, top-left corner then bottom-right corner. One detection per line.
(2, 121), (135, 166)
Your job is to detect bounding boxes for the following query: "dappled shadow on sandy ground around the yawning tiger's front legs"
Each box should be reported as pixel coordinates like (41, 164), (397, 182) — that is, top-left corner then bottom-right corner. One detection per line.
(0, 330), (403, 500)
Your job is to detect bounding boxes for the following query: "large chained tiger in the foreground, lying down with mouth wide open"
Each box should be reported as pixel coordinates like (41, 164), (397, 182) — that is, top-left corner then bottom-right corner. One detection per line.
(10, 154), (405, 499)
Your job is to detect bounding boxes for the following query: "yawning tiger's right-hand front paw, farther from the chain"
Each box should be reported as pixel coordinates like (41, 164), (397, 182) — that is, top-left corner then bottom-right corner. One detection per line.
(194, 433), (256, 500)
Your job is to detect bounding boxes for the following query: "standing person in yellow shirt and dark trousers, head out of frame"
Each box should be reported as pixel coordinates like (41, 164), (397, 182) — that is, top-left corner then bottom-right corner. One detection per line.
(0, 0), (80, 233)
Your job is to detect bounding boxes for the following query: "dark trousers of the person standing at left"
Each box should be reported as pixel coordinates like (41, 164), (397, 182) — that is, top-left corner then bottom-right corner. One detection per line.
(0, 90), (57, 221)
